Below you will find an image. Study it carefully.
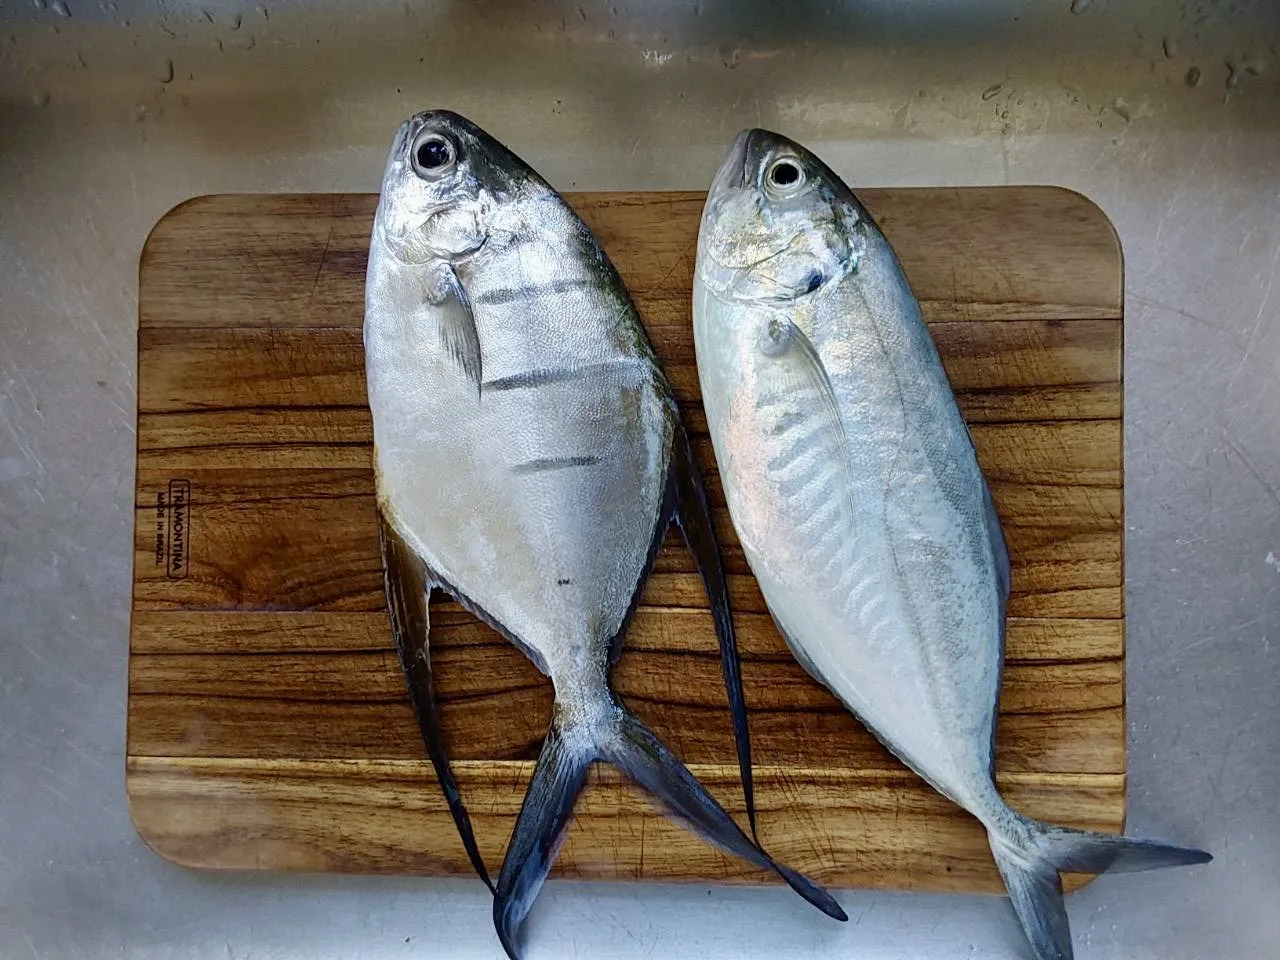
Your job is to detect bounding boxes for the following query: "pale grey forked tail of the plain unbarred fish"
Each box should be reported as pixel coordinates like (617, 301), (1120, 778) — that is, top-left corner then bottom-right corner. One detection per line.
(989, 814), (1213, 960)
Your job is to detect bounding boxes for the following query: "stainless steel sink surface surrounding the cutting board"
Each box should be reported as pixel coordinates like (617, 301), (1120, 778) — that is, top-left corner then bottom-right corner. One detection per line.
(0, 0), (1280, 960)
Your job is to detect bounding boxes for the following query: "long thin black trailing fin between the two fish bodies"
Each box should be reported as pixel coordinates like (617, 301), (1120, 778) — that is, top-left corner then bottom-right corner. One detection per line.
(671, 426), (759, 840)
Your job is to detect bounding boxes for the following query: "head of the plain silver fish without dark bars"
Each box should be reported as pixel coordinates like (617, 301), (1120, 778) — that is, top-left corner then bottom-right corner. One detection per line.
(698, 129), (872, 303)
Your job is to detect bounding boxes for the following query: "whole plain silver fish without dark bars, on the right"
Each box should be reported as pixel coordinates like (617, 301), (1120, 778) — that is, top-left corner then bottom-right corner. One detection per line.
(692, 129), (1211, 960)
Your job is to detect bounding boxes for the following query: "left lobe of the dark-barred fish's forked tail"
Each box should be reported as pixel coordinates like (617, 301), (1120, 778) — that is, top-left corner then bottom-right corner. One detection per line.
(493, 716), (595, 960)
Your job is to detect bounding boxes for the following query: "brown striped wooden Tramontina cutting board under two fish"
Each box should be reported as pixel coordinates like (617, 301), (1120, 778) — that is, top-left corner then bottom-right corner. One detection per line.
(128, 187), (1125, 891)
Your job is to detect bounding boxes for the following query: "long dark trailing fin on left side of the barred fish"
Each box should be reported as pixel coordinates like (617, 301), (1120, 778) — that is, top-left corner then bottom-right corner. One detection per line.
(379, 511), (494, 892)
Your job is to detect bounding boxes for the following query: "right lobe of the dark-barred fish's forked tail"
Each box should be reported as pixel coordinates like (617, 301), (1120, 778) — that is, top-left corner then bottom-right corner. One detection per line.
(600, 708), (849, 920)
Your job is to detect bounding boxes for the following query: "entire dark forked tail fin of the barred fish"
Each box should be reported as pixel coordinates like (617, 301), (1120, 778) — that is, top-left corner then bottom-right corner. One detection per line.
(493, 705), (849, 960)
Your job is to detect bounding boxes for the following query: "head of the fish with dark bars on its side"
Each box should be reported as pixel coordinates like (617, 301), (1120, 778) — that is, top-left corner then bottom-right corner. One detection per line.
(374, 110), (536, 264)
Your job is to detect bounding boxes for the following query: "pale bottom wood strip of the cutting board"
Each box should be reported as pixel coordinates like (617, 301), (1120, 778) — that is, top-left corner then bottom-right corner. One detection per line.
(128, 756), (1124, 896)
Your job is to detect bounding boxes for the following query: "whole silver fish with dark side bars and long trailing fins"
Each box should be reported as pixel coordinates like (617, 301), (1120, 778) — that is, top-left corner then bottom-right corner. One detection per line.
(364, 110), (845, 959)
